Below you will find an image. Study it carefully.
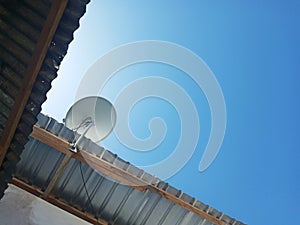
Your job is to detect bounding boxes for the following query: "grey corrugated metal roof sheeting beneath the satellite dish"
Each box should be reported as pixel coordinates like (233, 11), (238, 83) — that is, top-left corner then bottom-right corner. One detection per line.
(15, 114), (246, 225)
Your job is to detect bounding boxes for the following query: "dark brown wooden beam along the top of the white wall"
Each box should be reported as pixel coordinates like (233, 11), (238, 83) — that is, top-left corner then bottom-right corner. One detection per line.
(11, 178), (108, 225)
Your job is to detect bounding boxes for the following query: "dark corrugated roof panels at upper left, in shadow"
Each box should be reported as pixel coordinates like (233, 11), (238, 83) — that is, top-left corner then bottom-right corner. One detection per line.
(0, 0), (89, 198)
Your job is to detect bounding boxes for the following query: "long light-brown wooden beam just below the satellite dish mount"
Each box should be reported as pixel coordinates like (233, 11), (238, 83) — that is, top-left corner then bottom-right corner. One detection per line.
(31, 126), (226, 225)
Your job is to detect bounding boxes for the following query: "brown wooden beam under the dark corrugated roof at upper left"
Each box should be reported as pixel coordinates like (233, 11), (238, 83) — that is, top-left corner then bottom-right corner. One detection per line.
(0, 0), (68, 165)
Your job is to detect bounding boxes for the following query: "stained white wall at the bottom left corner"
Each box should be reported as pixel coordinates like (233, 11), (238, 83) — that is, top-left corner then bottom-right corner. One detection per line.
(0, 185), (90, 225)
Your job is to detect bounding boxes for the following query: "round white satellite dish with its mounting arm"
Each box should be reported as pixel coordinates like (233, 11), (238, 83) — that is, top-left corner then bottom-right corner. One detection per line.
(65, 96), (116, 152)
